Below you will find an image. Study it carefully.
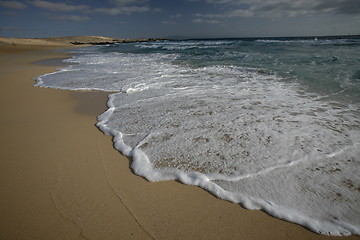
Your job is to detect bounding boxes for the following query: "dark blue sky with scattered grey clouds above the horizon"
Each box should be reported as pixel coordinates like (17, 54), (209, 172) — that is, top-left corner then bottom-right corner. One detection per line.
(0, 0), (360, 38)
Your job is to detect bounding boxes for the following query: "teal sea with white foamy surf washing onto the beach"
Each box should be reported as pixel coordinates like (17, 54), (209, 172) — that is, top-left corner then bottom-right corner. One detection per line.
(36, 37), (360, 235)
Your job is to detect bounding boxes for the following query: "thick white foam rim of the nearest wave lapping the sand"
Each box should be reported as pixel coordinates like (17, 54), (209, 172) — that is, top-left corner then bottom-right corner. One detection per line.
(96, 93), (360, 236)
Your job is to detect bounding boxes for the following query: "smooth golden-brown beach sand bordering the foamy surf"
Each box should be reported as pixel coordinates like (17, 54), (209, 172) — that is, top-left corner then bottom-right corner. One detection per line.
(0, 38), (360, 240)
